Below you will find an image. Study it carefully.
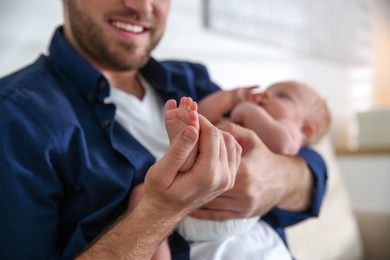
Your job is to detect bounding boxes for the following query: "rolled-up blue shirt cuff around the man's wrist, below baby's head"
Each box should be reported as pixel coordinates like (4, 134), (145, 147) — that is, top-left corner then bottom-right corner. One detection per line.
(263, 148), (327, 230)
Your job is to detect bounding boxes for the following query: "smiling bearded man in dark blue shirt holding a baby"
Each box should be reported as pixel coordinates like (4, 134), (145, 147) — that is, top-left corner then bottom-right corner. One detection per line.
(0, 0), (326, 259)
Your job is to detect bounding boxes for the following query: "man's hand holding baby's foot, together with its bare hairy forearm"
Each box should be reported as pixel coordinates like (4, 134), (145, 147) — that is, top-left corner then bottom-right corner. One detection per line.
(80, 116), (242, 259)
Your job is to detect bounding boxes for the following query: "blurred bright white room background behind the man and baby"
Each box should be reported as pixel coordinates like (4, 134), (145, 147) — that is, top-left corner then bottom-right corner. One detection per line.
(0, 0), (390, 258)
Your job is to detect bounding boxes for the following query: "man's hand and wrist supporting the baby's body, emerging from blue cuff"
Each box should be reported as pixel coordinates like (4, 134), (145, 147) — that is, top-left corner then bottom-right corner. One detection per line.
(192, 123), (313, 220)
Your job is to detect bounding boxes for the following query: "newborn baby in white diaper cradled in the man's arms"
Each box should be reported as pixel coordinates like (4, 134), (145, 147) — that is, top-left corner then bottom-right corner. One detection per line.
(176, 81), (330, 244)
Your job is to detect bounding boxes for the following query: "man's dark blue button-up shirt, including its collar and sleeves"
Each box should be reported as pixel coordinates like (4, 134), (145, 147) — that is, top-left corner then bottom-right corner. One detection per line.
(0, 28), (326, 259)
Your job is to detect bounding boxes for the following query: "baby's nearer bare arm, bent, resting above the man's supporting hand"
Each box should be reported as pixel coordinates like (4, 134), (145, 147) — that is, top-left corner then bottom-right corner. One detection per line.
(231, 102), (303, 155)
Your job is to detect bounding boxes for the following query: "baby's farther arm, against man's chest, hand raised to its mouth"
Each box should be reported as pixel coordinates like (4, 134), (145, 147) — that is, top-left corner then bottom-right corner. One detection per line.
(198, 86), (258, 124)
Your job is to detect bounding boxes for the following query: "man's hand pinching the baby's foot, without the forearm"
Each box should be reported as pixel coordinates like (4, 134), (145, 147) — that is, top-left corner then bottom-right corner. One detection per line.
(145, 116), (242, 216)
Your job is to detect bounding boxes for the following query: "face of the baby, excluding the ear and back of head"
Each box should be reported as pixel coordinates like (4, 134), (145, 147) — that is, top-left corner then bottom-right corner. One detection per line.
(260, 82), (316, 125)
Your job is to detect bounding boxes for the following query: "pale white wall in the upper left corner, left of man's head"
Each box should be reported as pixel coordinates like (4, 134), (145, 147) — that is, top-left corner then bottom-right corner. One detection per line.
(0, 0), (63, 76)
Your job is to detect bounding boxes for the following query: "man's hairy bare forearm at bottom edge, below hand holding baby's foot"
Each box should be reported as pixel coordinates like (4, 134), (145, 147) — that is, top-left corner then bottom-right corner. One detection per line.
(78, 198), (180, 260)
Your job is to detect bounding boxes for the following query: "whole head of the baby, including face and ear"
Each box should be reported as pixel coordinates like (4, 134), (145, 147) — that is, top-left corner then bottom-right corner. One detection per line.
(261, 81), (330, 145)
